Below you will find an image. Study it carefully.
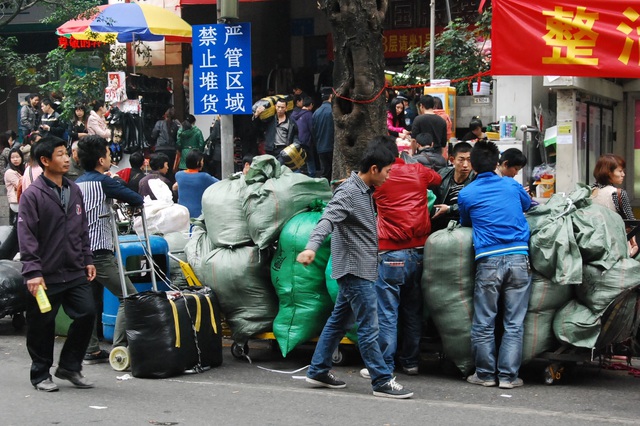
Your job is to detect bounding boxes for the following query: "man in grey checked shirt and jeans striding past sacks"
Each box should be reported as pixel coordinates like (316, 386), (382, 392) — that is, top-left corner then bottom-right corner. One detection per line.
(297, 143), (413, 399)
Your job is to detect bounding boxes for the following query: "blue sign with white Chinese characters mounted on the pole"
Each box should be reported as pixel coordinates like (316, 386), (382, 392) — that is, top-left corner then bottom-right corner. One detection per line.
(192, 23), (251, 115)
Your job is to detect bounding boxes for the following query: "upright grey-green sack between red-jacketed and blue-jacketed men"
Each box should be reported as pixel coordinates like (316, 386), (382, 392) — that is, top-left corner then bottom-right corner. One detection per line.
(422, 221), (475, 376)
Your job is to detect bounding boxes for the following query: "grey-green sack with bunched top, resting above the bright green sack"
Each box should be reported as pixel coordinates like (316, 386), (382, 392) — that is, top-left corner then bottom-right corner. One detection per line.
(244, 155), (332, 249)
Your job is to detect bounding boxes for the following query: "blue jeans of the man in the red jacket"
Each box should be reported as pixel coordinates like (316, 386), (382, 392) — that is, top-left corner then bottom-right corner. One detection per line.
(376, 249), (422, 371)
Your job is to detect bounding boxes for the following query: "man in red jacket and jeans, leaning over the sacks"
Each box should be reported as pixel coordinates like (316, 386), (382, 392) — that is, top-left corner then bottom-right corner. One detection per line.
(361, 136), (442, 377)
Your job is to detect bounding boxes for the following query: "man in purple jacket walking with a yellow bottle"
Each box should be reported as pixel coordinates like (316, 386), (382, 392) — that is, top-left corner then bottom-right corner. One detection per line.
(18, 136), (96, 392)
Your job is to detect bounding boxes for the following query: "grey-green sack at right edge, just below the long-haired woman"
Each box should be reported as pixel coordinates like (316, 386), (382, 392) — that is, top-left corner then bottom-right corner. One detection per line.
(576, 256), (640, 314)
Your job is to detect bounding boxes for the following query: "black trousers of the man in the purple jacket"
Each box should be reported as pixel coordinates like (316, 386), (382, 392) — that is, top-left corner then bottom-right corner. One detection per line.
(27, 278), (96, 385)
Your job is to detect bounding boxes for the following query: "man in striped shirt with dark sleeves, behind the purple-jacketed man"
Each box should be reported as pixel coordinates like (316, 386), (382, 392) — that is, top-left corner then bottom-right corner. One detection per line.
(76, 135), (143, 364)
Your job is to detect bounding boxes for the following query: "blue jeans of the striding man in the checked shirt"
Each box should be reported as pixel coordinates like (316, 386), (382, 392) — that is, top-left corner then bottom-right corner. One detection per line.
(307, 274), (392, 389)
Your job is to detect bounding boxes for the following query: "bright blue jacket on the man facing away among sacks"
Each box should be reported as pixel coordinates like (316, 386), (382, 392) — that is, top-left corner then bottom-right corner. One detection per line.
(458, 172), (531, 260)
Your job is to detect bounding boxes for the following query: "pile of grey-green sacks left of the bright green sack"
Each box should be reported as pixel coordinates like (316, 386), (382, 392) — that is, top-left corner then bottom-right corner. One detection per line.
(185, 155), (332, 353)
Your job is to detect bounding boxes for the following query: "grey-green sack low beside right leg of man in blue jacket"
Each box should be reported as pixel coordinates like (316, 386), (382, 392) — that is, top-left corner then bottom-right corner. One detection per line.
(522, 270), (574, 364)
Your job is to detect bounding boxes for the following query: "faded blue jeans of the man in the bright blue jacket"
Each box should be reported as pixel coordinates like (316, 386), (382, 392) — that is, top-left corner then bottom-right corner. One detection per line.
(471, 254), (531, 382)
